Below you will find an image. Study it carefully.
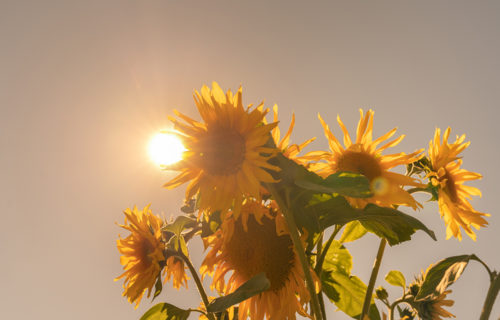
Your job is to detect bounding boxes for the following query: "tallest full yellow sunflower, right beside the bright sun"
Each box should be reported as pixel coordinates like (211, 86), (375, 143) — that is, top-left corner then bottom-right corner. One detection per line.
(165, 82), (279, 216)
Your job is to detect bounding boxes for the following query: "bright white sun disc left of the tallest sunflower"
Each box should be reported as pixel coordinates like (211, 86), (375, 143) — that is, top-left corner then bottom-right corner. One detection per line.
(149, 133), (186, 165)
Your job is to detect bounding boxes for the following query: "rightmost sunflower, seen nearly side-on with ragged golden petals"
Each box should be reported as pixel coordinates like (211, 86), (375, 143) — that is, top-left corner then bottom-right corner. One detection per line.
(429, 128), (489, 240)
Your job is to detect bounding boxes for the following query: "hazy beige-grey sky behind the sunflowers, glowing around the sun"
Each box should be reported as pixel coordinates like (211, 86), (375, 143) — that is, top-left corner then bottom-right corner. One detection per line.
(0, 0), (500, 320)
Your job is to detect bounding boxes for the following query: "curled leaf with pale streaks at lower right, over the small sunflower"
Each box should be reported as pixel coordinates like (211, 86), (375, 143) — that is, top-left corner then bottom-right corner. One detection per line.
(415, 254), (478, 300)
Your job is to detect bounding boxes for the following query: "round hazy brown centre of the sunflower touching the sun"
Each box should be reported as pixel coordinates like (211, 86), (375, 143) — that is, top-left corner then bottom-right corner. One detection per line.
(200, 130), (245, 175)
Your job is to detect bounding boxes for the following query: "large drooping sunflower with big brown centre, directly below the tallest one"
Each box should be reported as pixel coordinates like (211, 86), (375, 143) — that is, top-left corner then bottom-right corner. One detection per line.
(201, 201), (310, 320)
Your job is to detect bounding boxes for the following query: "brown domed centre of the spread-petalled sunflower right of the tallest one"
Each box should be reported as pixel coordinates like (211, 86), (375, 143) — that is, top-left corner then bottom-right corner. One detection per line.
(337, 150), (382, 181)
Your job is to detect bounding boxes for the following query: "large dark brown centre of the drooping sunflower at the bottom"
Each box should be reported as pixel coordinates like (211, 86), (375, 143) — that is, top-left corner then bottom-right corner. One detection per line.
(226, 215), (295, 291)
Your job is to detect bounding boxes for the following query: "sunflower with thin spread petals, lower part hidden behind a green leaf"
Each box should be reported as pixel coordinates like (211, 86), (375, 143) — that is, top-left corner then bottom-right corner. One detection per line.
(309, 110), (424, 209)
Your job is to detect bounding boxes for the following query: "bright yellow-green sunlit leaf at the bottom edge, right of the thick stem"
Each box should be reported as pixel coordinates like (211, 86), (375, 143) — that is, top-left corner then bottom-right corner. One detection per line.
(322, 271), (380, 320)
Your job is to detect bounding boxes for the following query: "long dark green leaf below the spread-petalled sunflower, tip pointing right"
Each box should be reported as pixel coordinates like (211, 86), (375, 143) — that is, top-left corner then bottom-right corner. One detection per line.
(309, 195), (436, 246)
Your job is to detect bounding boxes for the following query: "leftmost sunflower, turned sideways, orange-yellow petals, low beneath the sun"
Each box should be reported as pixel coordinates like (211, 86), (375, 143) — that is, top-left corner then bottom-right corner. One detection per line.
(115, 206), (165, 308)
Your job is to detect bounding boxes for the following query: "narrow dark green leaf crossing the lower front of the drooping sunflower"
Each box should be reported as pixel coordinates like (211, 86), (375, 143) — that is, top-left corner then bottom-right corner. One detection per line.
(207, 273), (271, 312)
